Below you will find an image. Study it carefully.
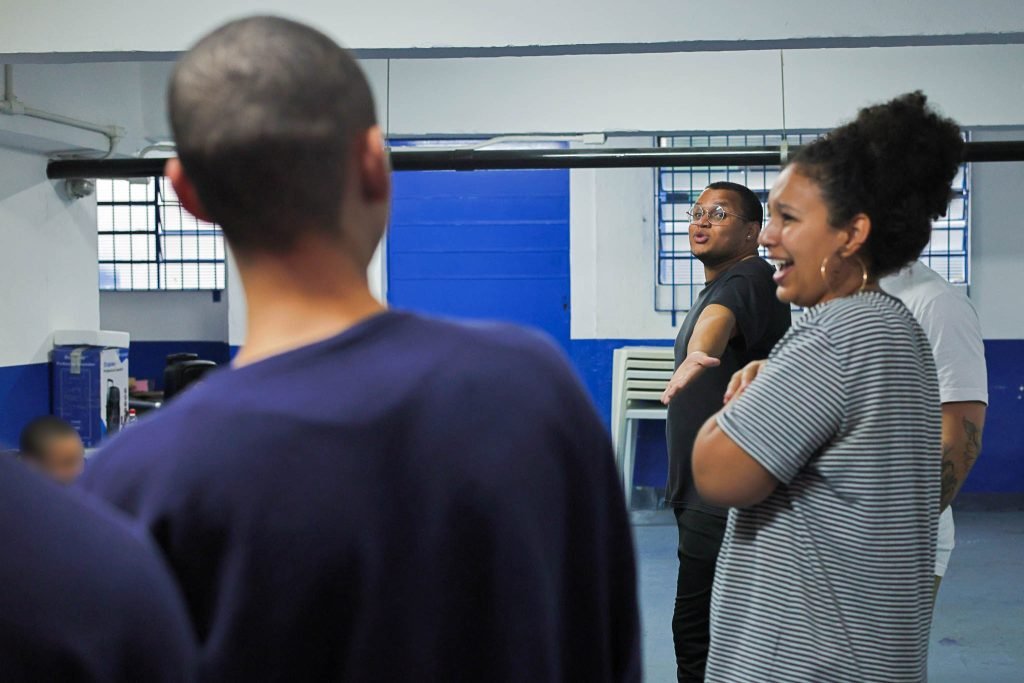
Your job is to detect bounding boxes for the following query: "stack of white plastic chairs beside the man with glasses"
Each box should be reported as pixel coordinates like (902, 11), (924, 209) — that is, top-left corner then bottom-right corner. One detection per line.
(611, 346), (675, 506)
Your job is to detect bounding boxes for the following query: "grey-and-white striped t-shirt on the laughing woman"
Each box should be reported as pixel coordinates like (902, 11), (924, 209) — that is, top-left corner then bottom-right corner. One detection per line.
(707, 292), (941, 683)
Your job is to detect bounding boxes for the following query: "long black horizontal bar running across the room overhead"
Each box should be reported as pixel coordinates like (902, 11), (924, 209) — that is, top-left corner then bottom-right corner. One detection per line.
(46, 140), (1024, 180)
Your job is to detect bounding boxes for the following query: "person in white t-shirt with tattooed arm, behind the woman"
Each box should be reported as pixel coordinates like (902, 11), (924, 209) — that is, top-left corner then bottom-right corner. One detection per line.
(881, 261), (988, 591)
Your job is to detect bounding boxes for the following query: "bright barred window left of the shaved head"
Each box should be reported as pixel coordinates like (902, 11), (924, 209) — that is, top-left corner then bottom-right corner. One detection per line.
(96, 178), (227, 291)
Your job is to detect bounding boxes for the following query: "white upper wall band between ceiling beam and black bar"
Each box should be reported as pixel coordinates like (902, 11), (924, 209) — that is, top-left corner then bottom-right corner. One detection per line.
(0, 44), (1024, 153)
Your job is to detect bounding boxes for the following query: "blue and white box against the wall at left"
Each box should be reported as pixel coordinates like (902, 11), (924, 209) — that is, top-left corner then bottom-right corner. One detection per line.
(52, 330), (130, 449)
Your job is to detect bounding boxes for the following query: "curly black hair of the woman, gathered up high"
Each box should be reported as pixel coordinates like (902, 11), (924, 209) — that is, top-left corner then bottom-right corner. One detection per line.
(792, 90), (964, 278)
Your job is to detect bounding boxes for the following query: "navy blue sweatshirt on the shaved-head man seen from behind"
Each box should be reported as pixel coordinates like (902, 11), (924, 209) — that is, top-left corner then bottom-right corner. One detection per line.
(83, 312), (640, 683)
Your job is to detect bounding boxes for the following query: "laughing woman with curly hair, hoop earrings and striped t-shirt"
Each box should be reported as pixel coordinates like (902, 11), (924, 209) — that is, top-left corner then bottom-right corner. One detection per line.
(693, 92), (963, 683)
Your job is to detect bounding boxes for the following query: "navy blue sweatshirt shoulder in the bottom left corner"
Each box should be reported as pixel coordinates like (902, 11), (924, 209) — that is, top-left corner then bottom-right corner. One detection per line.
(0, 456), (197, 683)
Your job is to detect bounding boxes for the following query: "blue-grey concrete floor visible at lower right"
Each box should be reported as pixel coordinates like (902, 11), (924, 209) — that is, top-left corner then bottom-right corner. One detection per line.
(633, 510), (1024, 683)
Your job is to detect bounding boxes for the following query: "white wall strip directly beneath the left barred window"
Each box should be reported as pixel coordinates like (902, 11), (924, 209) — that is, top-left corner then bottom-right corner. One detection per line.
(99, 292), (228, 343)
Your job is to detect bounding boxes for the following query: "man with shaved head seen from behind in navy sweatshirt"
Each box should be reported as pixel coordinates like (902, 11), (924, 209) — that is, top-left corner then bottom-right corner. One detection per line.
(82, 17), (640, 682)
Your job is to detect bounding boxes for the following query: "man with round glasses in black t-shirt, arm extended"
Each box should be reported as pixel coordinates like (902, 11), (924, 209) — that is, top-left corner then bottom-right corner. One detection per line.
(662, 181), (790, 681)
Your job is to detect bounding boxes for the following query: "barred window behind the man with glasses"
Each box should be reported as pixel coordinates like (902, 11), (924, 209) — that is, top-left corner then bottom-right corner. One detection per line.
(654, 133), (970, 325)
